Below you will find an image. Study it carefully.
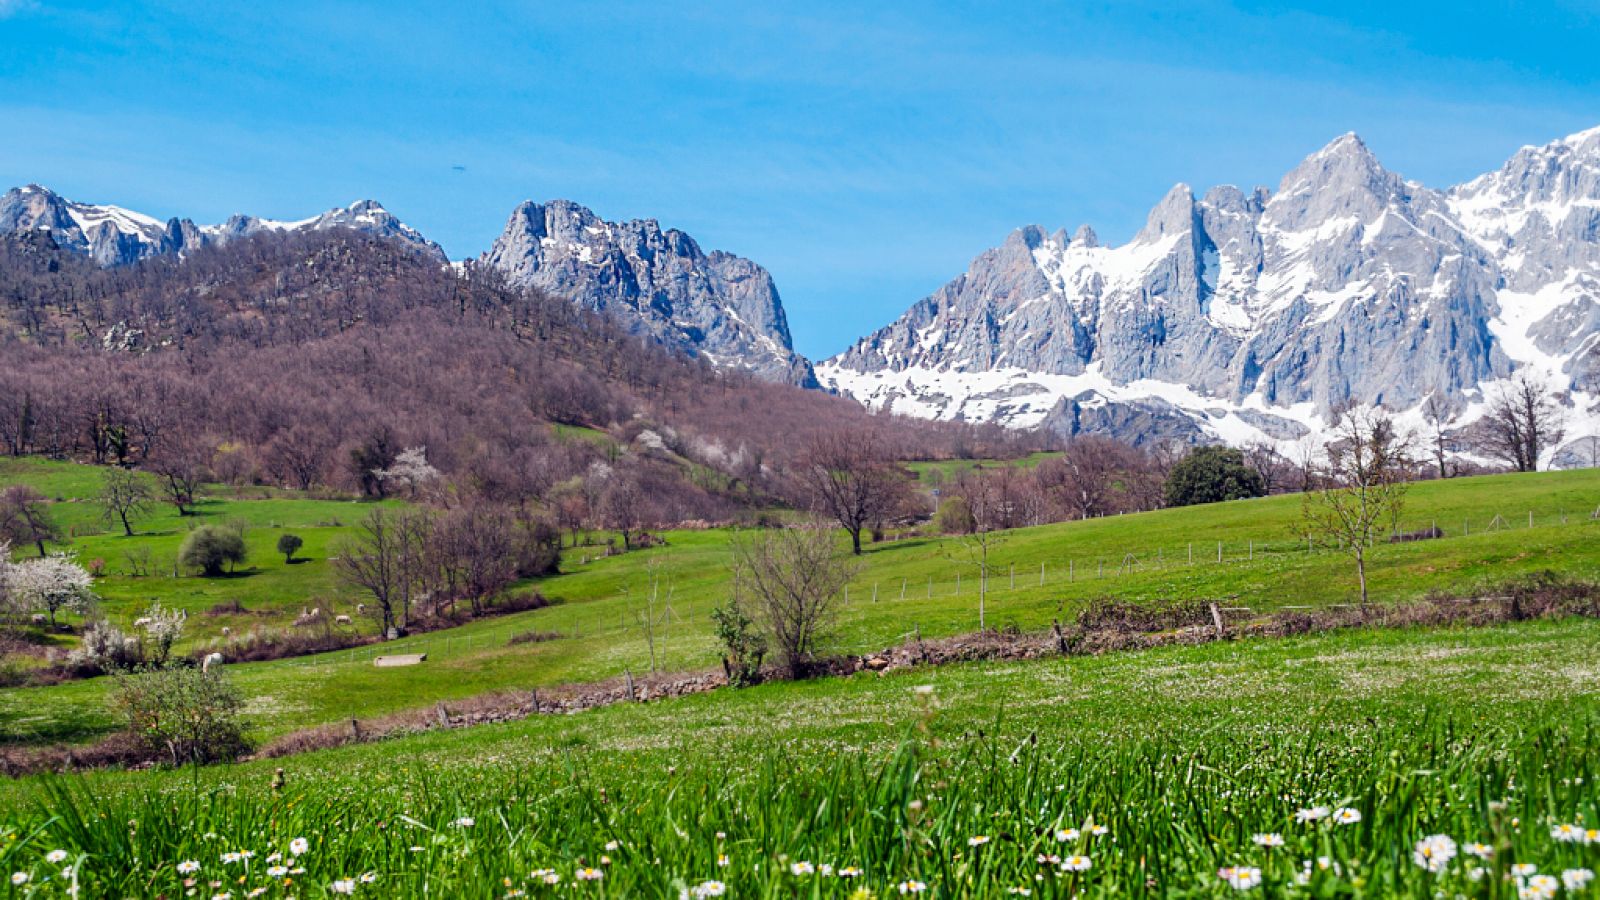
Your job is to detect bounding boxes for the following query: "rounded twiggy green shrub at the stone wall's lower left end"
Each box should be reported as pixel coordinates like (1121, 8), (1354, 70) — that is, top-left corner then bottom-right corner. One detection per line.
(112, 666), (250, 765)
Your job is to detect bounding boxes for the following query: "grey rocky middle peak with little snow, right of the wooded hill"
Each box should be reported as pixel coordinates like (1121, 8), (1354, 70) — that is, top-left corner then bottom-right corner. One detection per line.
(482, 200), (816, 386)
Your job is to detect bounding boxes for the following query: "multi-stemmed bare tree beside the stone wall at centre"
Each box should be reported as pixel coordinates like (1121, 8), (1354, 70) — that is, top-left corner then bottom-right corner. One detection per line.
(733, 525), (856, 677)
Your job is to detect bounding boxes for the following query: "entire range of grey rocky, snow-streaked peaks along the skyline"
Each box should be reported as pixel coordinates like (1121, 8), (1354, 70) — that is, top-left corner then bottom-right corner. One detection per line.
(9, 128), (1600, 447)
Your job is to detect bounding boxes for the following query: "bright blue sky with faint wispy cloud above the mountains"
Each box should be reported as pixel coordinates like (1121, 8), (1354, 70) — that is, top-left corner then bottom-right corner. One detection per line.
(0, 0), (1600, 357)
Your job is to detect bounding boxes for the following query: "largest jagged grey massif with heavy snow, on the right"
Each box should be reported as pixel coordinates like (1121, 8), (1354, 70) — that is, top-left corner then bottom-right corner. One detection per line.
(818, 128), (1600, 454)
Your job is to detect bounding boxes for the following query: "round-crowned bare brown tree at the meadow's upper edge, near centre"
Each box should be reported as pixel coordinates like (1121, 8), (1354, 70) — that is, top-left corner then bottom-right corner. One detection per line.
(798, 431), (906, 556)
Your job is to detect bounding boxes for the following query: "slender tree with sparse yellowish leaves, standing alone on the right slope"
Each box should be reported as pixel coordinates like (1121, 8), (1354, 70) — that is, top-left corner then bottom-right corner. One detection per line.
(1301, 408), (1408, 604)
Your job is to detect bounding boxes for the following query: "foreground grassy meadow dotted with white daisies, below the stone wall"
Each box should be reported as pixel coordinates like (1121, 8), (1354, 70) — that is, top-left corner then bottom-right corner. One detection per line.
(0, 620), (1600, 898)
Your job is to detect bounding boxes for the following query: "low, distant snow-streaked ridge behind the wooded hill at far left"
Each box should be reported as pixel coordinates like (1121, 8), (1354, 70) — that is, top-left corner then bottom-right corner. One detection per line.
(0, 184), (445, 266)
